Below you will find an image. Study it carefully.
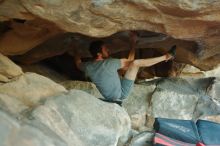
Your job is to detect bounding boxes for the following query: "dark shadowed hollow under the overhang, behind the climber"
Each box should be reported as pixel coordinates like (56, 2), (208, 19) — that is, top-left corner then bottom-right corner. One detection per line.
(1, 19), (205, 81)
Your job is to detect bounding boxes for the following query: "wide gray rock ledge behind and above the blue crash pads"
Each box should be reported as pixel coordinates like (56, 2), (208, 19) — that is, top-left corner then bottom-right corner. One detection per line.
(151, 78), (220, 120)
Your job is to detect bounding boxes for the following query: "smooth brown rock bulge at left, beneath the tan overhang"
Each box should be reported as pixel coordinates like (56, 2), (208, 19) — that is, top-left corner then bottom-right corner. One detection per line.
(0, 19), (61, 55)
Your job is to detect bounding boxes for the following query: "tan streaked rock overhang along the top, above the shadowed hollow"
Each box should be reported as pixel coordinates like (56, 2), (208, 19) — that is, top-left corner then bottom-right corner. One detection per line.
(12, 0), (220, 39)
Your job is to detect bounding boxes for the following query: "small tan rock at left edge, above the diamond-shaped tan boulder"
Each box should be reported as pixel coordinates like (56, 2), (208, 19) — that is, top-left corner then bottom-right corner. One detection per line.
(0, 53), (23, 82)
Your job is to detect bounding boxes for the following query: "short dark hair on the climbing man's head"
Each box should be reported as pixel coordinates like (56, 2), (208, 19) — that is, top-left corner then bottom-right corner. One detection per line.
(89, 40), (104, 58)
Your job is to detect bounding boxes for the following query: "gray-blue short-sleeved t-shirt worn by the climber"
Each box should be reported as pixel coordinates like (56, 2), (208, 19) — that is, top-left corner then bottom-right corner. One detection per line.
(80, 58), (122, 100)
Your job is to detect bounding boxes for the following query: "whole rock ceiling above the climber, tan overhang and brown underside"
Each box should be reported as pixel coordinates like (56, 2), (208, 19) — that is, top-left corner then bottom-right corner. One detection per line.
(0, 0), (220, 70)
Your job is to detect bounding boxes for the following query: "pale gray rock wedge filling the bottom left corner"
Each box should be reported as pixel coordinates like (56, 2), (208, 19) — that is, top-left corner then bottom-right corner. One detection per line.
(0, 110), (67, 146)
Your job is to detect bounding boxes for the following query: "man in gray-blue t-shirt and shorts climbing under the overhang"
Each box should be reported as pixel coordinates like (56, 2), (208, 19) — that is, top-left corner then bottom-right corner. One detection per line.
(75, 35), (176, 102)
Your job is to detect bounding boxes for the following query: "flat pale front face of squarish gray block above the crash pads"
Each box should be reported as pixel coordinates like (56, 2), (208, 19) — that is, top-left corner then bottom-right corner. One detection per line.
(151, 89), (198, 120)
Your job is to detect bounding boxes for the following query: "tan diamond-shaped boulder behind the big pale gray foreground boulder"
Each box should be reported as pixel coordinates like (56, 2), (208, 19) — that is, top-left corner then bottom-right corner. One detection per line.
(0, 73), (66, 106)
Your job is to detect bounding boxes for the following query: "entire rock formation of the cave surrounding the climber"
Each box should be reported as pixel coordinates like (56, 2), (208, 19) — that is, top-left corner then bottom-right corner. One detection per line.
(0, 0), (220, 146)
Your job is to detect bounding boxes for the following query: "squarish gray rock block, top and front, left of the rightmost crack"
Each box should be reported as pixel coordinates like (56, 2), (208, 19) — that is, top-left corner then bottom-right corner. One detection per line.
(151, 78), (199, 120)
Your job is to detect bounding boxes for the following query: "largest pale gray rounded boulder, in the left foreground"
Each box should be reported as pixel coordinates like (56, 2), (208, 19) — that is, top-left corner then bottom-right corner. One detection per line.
(0, 90), (131, 146)
